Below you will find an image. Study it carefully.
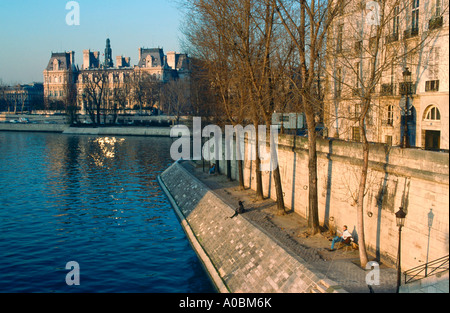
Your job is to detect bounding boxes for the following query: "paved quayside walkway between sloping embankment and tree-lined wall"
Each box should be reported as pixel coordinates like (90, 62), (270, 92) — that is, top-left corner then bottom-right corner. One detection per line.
(181, 162), (397, 293)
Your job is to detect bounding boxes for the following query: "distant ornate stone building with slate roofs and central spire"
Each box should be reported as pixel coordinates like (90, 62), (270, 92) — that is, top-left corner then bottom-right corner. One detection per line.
(43, 39), (190, 112)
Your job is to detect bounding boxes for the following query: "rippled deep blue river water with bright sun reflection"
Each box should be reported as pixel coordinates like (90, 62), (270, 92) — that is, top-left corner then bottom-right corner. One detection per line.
(0, 132), (215, 293)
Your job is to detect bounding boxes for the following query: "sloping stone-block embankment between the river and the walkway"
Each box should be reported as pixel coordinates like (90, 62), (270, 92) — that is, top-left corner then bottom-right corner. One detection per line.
(159, 162), (345, 293)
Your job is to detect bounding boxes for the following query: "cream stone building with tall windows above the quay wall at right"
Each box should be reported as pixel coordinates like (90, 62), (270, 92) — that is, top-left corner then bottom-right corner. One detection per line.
(324, 0), (449, 150)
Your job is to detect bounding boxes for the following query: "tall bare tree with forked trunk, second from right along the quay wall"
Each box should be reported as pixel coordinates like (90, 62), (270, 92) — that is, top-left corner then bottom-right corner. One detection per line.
(267, 0), (345, 233)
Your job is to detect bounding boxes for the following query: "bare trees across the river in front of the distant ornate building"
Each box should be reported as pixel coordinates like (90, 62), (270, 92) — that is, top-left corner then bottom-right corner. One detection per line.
(77, 69), (190, 124)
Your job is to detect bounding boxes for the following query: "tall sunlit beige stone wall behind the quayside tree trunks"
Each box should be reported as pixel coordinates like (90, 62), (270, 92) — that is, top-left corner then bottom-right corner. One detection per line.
(219, 135), (449, 270)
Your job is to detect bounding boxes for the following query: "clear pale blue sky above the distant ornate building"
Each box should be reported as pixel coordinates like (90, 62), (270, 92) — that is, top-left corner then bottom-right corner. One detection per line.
(0, 0), (183, 84)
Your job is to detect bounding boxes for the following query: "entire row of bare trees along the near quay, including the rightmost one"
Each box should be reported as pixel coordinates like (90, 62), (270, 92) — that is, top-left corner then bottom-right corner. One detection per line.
(184, 0), (448, 267)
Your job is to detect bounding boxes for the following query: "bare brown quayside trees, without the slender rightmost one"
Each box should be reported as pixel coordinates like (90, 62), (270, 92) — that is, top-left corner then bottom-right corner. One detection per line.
(181, 0), (343, 229)
